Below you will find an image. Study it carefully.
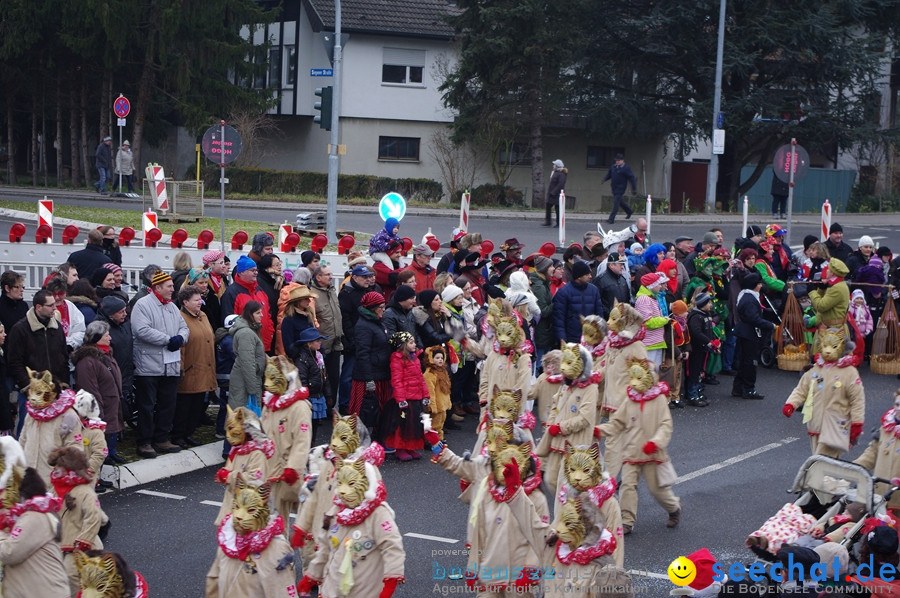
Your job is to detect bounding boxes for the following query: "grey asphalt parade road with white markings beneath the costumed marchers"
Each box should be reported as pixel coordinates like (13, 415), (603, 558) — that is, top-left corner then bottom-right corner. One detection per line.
(100, 366), (898, 598)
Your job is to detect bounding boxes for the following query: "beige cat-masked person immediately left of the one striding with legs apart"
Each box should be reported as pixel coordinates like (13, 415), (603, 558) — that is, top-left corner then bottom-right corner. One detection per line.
(535, 343), (601, 493)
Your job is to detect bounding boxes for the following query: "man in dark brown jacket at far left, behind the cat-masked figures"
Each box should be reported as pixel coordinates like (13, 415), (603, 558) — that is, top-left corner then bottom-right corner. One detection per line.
(6, 289), (69, 435)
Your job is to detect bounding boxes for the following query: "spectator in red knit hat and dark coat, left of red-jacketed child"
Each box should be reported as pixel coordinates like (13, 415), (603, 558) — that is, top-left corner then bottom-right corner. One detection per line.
(349, 291), (392, 428)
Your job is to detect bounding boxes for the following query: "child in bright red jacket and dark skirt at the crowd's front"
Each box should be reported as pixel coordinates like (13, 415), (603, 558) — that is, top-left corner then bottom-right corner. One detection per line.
(380, 331), (431, 461)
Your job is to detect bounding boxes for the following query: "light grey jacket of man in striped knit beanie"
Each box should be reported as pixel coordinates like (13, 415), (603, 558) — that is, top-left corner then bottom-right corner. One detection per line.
(131, 293), (188, 376)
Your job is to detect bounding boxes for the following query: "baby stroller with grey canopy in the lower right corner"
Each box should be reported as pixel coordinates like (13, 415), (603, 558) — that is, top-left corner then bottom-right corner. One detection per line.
(748, 455), (898, 596)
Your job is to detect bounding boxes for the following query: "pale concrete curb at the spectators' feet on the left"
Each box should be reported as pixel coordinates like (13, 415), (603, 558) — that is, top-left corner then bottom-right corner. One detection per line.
(100, 440), (225, 490)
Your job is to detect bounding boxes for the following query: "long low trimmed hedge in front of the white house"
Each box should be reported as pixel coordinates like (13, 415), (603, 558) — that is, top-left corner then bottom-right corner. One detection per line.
(193, 166), (443, 203)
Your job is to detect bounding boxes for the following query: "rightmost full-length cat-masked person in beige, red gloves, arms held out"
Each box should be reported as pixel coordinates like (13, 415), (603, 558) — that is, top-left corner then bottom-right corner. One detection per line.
(782, 328), (866, 459)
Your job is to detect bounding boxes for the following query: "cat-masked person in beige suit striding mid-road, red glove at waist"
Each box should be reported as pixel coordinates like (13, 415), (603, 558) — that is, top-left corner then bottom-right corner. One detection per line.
(599, 359), (681, 536)
